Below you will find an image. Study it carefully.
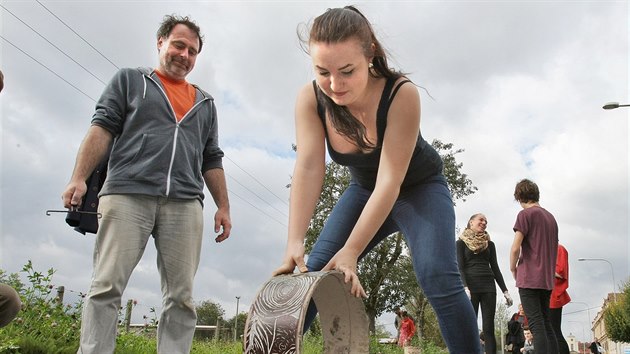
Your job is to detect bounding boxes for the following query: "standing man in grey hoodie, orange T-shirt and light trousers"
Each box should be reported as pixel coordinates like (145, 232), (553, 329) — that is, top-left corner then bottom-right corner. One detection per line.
(62, 16), (232, 354)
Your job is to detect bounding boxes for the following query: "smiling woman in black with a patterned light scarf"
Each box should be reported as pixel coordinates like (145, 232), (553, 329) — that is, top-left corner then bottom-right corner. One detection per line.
(457, 213), (512, 353)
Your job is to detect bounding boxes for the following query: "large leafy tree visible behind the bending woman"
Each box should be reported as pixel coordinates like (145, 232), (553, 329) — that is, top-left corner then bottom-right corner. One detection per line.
(293, 139), (477, 341)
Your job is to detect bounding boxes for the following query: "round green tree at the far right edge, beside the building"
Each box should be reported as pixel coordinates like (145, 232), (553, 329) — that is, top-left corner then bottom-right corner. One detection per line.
(604, 281), (630, 343)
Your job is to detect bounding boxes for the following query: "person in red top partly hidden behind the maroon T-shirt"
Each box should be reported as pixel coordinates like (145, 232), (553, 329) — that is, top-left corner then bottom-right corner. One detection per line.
(549, 245), (571, 354)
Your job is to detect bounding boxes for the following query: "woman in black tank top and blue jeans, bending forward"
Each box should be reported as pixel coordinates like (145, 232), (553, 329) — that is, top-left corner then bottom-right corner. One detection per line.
(274, 6), (480, 353)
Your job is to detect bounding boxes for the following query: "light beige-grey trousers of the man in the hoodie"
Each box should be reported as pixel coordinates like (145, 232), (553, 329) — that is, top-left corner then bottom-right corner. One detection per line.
(78, 195), (203, 354)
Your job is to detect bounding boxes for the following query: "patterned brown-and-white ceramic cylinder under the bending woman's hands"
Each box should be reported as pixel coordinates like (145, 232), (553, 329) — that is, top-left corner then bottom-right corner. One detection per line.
(244, 271), (369, 354)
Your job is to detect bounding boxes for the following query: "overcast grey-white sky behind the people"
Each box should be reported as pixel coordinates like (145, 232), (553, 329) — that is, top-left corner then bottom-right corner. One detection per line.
(0, 0), (630, 340)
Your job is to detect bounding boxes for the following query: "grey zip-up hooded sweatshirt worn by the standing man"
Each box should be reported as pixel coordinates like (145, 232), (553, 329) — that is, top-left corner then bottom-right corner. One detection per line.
(92, 68), (223, 201)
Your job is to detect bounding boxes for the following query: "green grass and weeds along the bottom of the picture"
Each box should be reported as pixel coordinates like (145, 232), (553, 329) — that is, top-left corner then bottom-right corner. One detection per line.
(0, 261), (447, 354)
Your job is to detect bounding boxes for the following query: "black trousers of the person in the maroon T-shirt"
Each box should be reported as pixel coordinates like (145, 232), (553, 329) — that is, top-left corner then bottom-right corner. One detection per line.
(518, 288), (558, 354)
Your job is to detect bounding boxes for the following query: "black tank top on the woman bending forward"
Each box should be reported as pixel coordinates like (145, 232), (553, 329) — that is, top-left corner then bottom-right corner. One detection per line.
(313, 78), (443, 190)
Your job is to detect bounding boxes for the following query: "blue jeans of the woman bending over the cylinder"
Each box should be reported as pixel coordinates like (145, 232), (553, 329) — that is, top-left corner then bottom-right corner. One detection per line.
(305, 175), (481, 354)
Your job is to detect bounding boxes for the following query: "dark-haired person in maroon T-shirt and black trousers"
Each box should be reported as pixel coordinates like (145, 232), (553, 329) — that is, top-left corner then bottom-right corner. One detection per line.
(510, 179), (558, 354)
